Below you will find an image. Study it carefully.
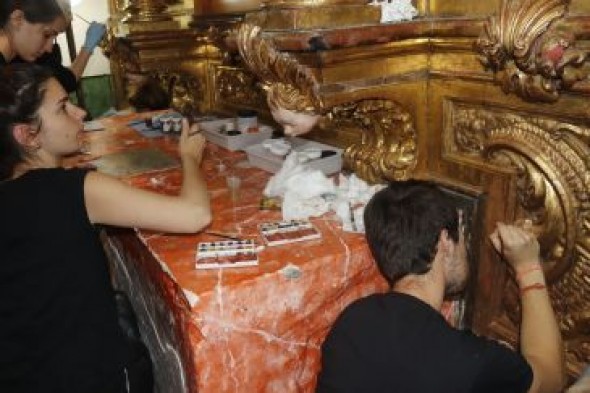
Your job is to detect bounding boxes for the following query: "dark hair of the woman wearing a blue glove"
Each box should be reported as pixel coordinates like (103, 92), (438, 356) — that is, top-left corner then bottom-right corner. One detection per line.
(0, 0), (64, 28)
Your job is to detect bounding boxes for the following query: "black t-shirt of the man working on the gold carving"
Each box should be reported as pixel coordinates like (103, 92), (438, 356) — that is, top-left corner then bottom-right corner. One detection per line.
(317, 292), (533, 393)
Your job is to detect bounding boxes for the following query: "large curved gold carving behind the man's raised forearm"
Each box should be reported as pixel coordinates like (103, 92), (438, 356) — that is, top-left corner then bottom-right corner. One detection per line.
(445, 105), (590, 374)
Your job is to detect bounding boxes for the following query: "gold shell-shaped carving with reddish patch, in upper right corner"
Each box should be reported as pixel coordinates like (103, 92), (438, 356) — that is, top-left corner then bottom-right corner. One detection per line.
(476, 0), (588, 102)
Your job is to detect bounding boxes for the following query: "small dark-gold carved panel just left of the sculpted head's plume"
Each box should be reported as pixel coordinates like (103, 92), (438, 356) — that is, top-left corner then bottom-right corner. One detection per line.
(215, 66), (265, 107)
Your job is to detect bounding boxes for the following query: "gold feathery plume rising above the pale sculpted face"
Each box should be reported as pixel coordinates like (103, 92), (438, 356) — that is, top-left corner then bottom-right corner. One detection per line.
(237, 18), (322, 113)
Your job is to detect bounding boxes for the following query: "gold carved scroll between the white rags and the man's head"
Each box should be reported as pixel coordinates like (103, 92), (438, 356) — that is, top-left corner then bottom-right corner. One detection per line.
(329, 100), (417, 183)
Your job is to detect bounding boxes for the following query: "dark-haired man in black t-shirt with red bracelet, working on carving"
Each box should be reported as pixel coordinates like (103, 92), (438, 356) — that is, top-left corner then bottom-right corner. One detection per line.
(317, 180), (564, 393)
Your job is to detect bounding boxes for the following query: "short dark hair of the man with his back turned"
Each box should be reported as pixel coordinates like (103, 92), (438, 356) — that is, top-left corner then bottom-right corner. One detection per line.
(364, 180), (459, 286)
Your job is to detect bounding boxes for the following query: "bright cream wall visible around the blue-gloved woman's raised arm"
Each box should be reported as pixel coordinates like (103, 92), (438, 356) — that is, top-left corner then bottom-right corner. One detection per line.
(57, 0), (111, 76)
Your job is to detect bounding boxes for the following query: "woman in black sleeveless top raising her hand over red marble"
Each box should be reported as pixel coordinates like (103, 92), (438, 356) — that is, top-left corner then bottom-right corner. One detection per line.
(0, 64), (211, 393)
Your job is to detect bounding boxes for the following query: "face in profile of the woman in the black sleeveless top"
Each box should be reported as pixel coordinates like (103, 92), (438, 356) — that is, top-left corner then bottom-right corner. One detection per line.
(38, 78), (86, 158)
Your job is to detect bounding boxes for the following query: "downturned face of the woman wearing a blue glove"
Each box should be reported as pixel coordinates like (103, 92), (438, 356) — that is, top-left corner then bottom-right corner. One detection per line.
(10, 11), (67, 62)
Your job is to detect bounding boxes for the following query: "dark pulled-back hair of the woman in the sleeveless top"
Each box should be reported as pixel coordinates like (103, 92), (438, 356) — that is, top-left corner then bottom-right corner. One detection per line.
(0, 64), (52, 181)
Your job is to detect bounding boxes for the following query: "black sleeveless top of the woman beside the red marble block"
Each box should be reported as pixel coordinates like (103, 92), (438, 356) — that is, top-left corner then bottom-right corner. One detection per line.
(0, 169), (127, 393)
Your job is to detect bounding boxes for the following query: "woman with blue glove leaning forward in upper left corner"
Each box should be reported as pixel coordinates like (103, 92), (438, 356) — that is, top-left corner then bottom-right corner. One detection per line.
(0, 0), (106, 92)
